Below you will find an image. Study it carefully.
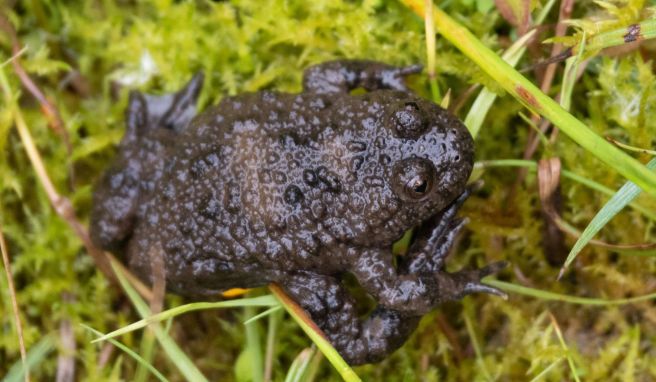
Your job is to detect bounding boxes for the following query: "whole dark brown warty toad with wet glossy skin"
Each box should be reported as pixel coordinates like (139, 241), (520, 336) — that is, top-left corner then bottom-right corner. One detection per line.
(91, 61), (499, 364)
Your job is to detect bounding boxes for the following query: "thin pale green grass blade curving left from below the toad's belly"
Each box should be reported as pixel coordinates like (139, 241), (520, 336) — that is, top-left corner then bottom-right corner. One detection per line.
(92, 295), (278, 342)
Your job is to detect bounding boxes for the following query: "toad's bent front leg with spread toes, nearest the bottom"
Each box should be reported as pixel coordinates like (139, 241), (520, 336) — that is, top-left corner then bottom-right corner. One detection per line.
(352, 189), (505, 315)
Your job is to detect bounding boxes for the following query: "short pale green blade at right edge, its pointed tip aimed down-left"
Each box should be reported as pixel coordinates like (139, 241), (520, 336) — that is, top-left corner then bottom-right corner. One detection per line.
(560, 158), (656, 275)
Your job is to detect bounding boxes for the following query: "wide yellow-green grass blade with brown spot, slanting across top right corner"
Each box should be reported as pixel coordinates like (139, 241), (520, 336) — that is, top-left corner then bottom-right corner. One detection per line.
(403, 0), (656, 196)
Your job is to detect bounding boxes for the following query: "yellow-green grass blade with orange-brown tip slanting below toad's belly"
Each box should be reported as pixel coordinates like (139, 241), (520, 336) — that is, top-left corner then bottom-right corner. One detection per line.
(269, 284), (362, 382)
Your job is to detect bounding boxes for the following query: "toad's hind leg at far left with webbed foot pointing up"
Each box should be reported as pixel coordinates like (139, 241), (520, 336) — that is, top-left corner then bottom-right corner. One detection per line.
(89, 73), (203, 252)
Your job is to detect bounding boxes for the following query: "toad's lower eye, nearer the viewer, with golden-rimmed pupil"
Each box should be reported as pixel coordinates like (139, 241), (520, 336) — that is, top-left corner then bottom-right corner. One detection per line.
(392, 158), (437, 201)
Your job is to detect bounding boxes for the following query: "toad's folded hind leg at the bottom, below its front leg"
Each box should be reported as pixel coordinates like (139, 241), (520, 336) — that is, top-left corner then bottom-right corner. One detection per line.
(281, 272), (420, 365)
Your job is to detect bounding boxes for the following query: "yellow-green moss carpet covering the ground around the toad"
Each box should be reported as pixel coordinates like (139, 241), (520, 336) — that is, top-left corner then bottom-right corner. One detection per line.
(0, 0), (656, 381)
